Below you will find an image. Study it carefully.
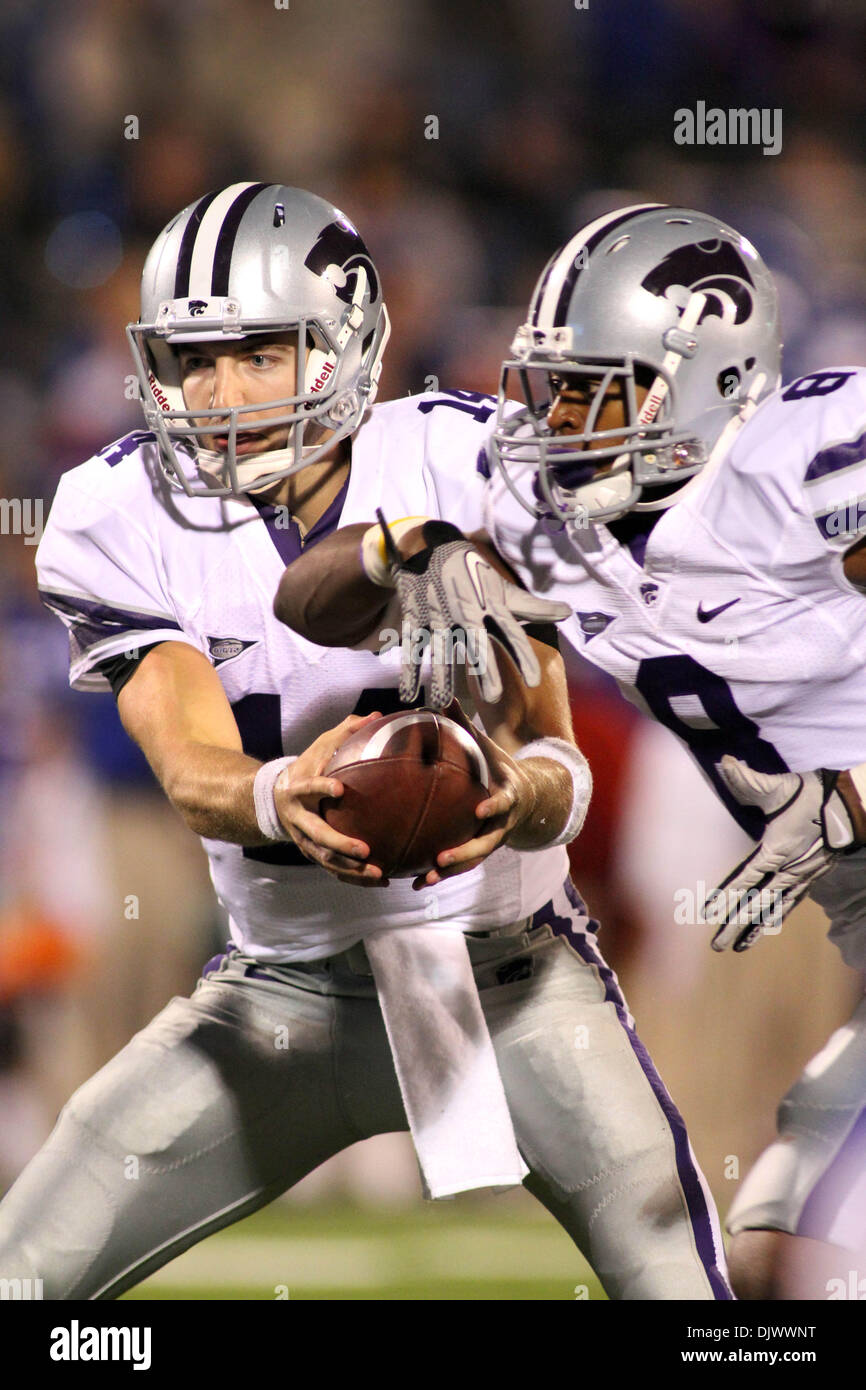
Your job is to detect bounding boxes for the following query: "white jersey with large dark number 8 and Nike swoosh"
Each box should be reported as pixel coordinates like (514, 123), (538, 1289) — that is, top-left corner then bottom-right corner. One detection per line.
(485, 368), (866, 838)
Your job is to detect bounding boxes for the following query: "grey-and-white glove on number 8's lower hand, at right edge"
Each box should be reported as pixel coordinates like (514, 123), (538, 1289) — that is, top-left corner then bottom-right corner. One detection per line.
(703, 753), (859, 951)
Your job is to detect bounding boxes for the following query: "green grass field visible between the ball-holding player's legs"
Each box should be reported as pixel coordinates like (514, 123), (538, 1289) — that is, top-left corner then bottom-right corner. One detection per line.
(125, 1194), (605, 1300)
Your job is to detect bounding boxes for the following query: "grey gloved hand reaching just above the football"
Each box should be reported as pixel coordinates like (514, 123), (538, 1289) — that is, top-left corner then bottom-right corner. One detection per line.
(377, 512), (571, 709)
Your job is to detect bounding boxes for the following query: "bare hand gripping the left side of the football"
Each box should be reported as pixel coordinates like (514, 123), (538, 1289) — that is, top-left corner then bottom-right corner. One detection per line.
(274, 712), (388, 888)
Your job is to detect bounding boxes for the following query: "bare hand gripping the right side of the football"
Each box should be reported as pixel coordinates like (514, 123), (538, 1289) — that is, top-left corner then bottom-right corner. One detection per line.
(413, 701), (535, 890)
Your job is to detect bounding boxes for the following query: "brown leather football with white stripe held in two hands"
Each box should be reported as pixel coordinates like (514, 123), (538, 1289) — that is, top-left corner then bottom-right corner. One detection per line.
(321, 709), (489, 878)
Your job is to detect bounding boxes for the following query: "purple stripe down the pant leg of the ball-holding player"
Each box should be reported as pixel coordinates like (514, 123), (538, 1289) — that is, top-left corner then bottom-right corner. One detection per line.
(541, 881), (734, 1300)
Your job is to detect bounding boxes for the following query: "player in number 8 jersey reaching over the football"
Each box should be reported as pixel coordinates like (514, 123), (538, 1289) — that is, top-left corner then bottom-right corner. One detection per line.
(301, 204), (866, 1298)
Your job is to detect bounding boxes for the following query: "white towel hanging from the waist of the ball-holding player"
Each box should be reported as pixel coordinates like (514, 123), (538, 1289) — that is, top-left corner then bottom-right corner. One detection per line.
(364, 926), (528, 1198)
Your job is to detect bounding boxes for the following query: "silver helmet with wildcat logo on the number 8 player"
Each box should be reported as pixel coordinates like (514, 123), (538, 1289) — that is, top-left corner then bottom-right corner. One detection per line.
(492, 203), (781, 523)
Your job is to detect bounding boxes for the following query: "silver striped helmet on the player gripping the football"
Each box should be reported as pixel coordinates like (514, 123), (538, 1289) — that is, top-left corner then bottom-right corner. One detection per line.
(126, 183), (391, 496)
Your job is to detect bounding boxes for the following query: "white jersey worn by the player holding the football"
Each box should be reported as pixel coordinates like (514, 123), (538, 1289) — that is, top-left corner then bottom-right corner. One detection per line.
(36, 392), (567, 962)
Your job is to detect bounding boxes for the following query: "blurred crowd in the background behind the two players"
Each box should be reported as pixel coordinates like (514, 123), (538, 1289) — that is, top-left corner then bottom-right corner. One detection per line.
(0, 0), (866, 1217)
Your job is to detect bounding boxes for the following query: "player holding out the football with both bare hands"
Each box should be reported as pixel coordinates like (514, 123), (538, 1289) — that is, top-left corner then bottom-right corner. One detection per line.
(0, 183), (730, 1300)
